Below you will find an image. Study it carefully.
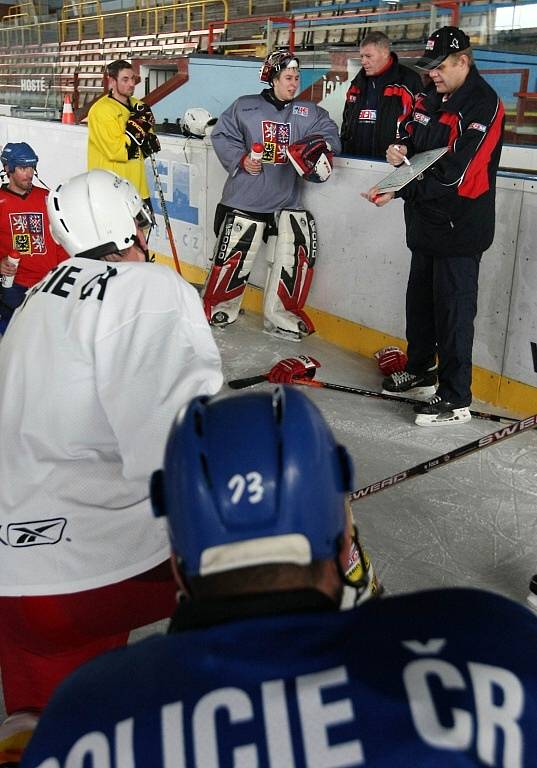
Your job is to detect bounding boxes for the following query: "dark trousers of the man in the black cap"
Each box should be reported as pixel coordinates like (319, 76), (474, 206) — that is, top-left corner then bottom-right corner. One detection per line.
(406, 251), (481, 407)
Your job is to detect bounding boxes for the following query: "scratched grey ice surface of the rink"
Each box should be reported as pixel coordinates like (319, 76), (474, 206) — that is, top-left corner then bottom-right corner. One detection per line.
(0, 314), (537, 720)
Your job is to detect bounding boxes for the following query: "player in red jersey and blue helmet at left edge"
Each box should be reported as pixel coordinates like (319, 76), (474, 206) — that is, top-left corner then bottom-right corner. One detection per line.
(0, 141), (67, 335)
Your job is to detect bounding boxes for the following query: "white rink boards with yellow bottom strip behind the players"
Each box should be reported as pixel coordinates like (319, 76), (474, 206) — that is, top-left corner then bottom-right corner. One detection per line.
(0, 117), (537, 413)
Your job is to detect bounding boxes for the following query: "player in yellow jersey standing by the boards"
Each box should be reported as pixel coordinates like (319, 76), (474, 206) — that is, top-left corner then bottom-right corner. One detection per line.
(88, 59), (160, 205)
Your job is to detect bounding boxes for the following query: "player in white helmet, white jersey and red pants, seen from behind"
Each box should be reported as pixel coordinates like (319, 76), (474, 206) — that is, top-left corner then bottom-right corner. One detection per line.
(0, 170), (222, 764)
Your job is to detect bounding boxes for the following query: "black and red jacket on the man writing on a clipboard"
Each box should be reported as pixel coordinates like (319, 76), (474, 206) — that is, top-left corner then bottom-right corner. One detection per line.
(397, 66), (504, 256)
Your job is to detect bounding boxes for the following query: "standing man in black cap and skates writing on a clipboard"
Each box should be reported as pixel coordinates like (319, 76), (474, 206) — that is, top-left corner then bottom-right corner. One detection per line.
(363, 27), (504, 426)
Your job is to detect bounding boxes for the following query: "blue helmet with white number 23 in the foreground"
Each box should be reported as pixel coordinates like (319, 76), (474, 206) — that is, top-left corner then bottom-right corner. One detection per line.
(151, 387), (353, 576)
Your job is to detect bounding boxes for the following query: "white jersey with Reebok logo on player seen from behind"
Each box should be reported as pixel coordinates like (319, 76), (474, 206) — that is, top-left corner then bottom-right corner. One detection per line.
(0, 257), (223, 595)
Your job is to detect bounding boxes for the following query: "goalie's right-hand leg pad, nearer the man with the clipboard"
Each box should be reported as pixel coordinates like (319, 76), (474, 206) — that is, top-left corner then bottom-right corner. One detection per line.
(263, 210), (317, 341)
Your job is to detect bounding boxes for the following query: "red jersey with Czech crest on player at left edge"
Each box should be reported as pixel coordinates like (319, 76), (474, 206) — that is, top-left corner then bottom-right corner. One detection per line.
(0, 187), (68, 288)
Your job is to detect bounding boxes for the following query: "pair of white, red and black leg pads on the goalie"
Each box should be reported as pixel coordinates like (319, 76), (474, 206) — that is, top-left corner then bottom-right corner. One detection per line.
(202, 210), (317, 341)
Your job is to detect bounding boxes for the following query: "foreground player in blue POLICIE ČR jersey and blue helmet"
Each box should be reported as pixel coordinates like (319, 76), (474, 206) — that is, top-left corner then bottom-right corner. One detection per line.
(18, 387), (537, 768)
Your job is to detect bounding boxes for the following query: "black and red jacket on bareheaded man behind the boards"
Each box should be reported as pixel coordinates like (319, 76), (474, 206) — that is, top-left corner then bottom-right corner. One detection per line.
(341, 53), (423, 160)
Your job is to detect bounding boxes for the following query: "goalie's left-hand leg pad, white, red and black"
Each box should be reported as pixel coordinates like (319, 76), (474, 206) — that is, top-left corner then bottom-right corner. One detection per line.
(202, 211), (265, 325)
